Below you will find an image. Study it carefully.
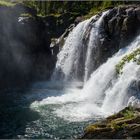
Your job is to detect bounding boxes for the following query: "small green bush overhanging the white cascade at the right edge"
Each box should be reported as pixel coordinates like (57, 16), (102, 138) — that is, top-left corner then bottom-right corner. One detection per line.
(116, 48), (140, 74)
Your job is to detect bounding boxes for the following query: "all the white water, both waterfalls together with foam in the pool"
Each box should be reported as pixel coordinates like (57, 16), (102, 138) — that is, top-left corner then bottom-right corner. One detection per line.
(31, 12), (140, 121)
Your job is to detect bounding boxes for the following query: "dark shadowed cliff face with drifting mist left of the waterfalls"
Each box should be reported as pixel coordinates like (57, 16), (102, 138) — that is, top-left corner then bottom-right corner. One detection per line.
(0, 4), (76, 88)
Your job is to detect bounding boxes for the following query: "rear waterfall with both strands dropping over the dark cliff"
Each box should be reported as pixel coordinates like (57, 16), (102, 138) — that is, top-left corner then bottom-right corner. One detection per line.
(52, 12), (107, 81)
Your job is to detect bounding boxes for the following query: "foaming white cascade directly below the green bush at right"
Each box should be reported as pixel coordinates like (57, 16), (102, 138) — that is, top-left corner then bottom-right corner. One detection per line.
(102, 62), (140, 114)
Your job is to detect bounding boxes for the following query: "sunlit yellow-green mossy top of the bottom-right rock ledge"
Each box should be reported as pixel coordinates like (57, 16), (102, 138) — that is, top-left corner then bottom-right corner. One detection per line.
(85, 107), (136, 136)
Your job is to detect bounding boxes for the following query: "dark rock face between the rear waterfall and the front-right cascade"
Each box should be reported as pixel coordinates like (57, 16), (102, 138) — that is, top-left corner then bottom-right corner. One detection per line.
(96, 6), (140, 71)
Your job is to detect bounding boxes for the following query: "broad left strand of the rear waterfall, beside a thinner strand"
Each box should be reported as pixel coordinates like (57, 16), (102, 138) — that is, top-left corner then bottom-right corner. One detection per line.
(52, 19), (91, 80)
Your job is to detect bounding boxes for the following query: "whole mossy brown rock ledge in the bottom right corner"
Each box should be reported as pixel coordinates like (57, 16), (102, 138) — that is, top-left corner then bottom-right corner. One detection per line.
(82, 107), (140, 139)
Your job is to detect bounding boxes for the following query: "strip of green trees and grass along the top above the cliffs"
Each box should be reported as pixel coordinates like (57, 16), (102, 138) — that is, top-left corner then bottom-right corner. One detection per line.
(0, 0), (138, 18)
